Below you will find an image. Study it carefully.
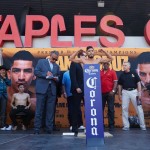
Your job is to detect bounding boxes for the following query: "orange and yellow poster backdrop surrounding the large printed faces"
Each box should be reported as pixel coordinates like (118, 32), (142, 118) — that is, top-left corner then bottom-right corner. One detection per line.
(2, 47), (150, 127)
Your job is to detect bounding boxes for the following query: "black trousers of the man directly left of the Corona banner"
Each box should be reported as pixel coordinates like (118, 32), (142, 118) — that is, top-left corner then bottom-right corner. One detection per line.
(71, 93), (83, 132)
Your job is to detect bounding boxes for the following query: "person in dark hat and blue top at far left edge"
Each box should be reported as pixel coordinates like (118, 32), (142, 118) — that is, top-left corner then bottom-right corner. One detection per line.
(0, 66), (11, 130)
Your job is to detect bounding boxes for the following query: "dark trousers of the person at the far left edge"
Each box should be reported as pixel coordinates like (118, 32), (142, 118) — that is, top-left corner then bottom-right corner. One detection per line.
(0, 94), (7, 127)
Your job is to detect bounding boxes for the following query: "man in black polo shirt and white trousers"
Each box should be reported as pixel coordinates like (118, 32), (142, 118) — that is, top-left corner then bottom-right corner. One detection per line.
(118, 62), (146, 131)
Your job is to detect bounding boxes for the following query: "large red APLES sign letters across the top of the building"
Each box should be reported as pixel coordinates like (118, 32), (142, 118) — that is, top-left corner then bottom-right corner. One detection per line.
(0, 14), (150, 47)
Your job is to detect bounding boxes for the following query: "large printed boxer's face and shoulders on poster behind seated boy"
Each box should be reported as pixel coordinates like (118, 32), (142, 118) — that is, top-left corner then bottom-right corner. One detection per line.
(8, 50), (36, 111)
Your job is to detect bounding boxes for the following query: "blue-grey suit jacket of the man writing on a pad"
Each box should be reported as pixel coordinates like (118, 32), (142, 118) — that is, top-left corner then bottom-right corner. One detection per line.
(34, 59), (60, 95)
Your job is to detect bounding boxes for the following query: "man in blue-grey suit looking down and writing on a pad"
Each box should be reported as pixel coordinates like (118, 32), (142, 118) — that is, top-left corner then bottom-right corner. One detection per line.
(34, 51), (60, 134)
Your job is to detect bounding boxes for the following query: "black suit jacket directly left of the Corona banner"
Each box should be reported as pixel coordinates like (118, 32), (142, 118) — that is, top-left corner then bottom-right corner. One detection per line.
(70, 62), (84, 94)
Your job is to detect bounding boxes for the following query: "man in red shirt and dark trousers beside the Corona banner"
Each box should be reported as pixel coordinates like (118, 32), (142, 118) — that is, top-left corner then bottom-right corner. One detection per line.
(101, 62), (118, 131)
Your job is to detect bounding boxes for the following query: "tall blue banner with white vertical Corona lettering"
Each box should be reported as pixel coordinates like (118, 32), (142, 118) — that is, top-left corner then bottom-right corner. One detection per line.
(84, 64), (104, 146)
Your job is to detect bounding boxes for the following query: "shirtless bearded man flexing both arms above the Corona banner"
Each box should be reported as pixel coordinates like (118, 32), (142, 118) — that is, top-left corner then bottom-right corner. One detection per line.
(69, 46), (113, 64)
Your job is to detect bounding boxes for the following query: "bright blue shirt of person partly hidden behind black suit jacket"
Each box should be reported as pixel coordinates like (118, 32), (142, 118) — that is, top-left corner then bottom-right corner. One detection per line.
(62, 70), (72, 97)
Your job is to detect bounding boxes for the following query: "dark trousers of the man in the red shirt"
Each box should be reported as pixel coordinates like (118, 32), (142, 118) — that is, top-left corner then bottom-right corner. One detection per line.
(102, 92), (114, 128)
